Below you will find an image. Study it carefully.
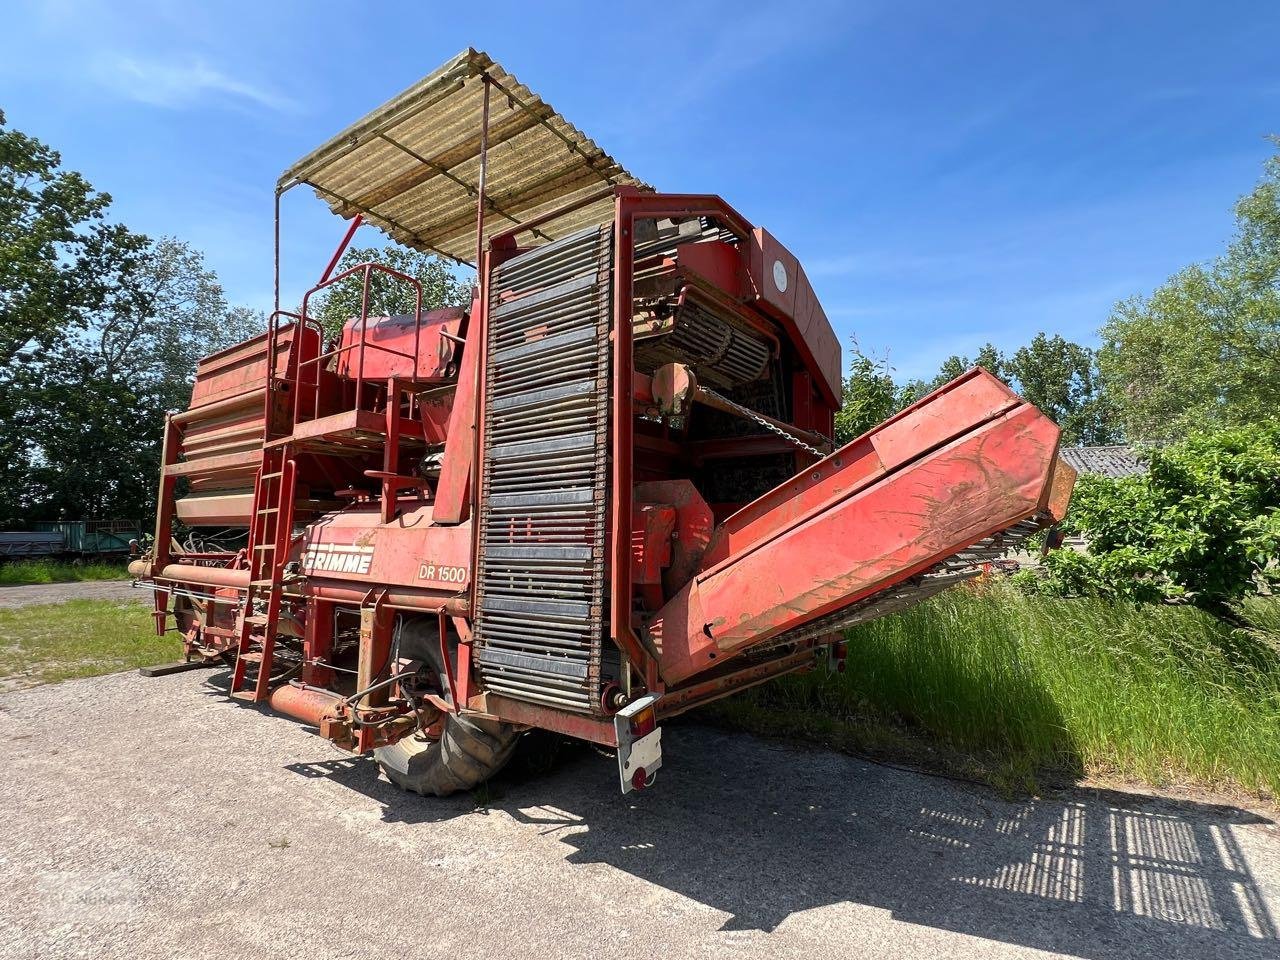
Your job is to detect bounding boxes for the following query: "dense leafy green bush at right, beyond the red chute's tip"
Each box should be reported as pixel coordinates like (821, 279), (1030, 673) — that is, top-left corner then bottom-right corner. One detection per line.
(1039, 425), (1280, 611)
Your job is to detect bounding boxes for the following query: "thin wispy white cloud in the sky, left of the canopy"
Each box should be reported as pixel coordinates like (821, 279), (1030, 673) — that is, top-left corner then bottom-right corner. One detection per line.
(92, 55), (298, 113)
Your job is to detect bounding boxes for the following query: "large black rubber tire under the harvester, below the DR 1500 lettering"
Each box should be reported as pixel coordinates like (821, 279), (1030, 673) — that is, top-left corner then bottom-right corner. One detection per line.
(374, 618), (521, 796)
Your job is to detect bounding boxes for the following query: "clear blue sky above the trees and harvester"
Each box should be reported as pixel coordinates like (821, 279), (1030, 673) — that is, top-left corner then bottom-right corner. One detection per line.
(0, 0), (1280, 378)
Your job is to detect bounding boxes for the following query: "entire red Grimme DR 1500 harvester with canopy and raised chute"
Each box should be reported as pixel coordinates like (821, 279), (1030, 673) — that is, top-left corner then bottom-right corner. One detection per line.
(132, 50), (1074, 795)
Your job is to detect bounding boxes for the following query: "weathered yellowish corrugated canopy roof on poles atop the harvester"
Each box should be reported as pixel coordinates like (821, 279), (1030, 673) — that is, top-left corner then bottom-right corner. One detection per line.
(278, 49), (648, 262)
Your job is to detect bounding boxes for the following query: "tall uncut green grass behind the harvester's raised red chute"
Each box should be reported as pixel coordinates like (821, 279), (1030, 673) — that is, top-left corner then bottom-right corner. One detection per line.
(701, 584), (1280, 795)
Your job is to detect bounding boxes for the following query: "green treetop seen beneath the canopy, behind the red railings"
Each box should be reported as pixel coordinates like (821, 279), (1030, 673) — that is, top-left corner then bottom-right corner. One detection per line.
(307, 244), (471, 337)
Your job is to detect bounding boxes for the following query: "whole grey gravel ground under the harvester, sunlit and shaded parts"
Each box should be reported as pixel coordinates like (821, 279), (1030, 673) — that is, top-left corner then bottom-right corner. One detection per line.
(0, 672), (1280, 960)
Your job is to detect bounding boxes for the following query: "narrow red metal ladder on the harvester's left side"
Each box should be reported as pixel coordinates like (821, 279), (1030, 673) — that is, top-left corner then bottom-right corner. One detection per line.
(230, 444), (296, 703)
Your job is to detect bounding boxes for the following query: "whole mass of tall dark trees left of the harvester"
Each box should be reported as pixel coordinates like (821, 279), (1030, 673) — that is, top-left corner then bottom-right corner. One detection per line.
(0, 112), (264, 525)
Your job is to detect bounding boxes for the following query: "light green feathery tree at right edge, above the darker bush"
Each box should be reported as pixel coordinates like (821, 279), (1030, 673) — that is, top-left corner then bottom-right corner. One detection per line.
(1100, 141), (1280, 442)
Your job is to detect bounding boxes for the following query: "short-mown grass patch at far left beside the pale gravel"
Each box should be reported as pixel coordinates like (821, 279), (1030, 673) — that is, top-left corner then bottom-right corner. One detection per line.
(0, 600), (182, 689)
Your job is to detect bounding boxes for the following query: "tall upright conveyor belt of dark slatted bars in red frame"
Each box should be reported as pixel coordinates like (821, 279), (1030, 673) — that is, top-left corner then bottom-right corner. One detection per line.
(474, 225), (613, 712)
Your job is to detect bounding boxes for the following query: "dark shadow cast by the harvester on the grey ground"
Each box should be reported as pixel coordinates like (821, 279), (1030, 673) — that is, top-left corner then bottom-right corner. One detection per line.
(275, 726), (1280, 960)
